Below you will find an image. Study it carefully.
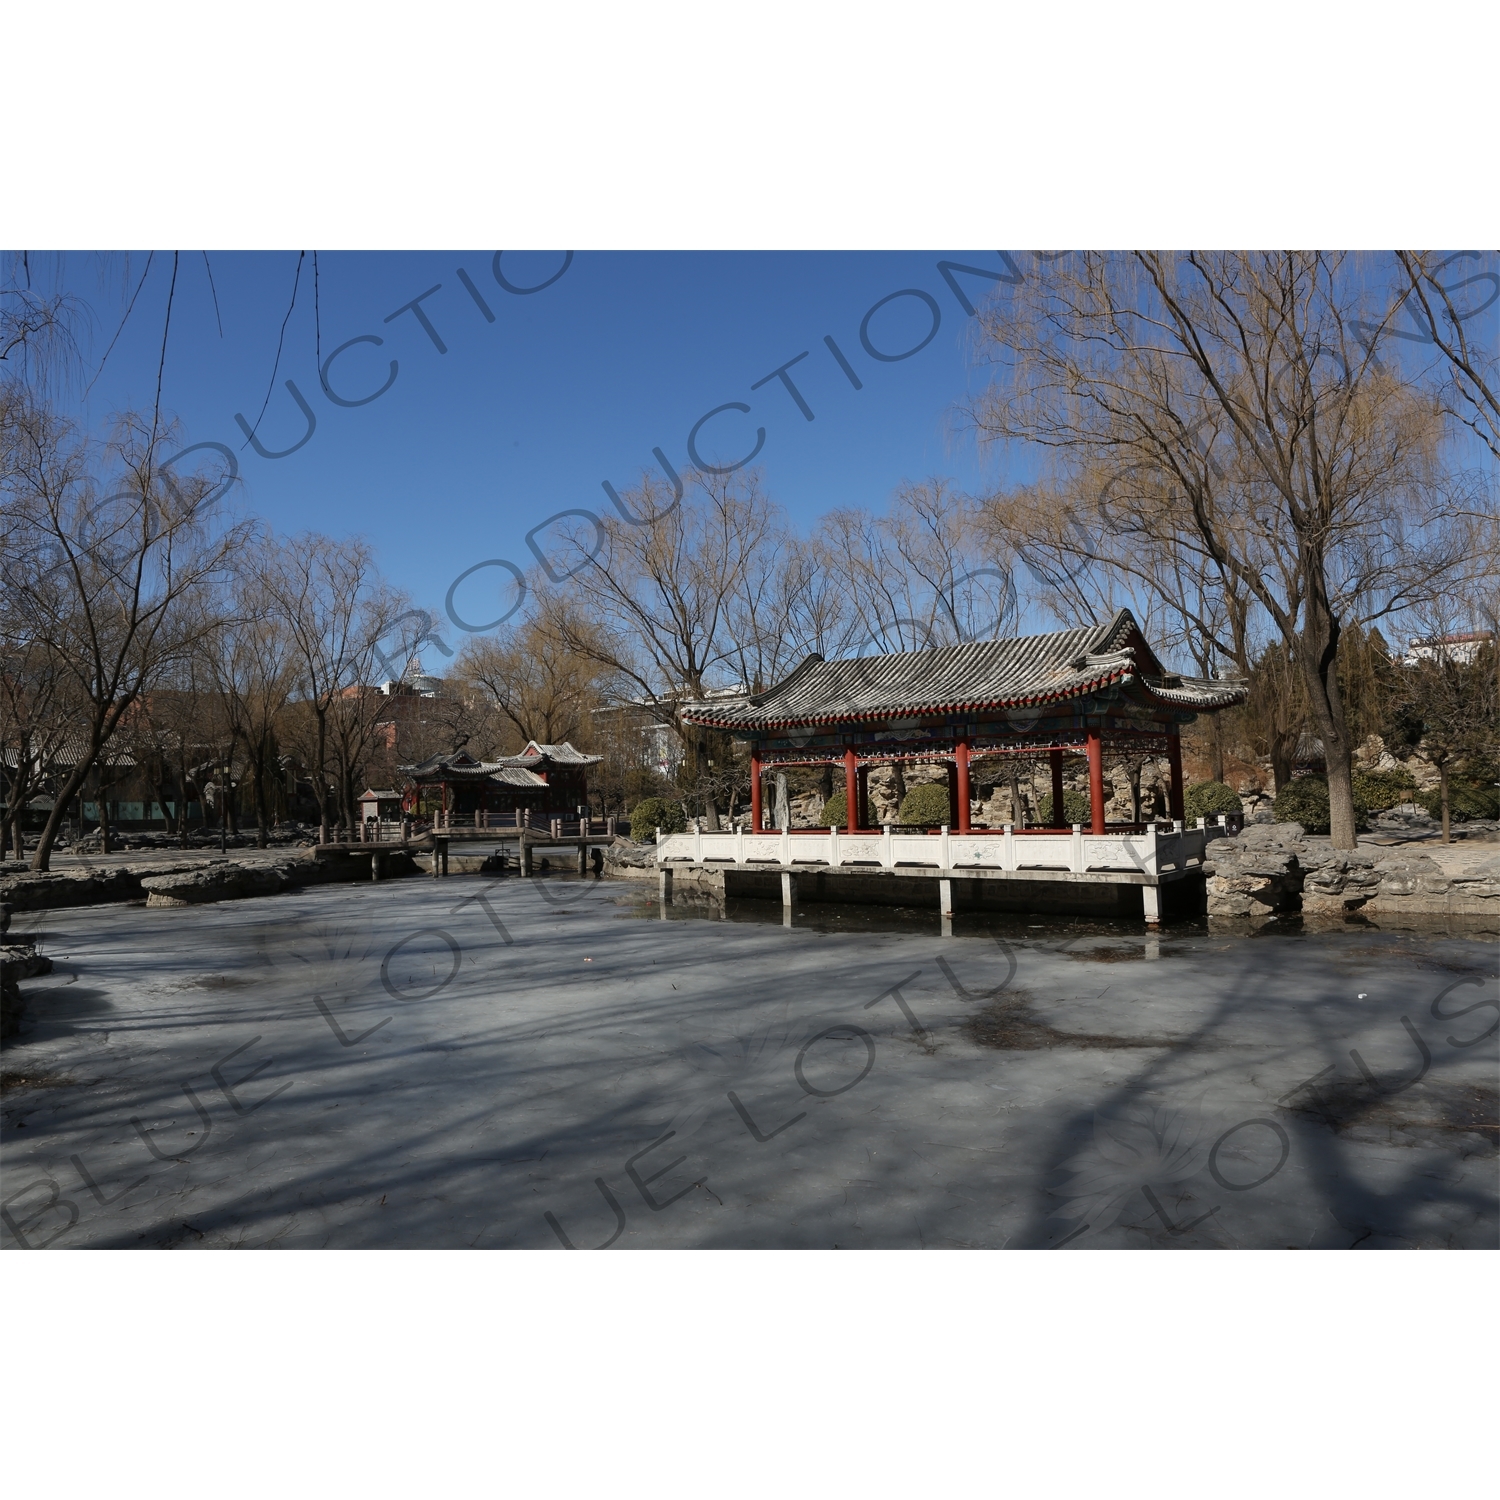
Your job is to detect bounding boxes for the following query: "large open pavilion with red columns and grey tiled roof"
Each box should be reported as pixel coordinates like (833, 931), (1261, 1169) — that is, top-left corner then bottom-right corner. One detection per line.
(681, 609), (1245, 834)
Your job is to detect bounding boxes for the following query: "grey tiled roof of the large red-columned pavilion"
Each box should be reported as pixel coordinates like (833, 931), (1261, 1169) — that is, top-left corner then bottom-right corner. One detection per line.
(681, 609), (1245, 731)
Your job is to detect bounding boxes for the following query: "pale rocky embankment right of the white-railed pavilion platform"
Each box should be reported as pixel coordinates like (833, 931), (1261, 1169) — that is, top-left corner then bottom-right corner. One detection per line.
(1203, 824), (1500, 924)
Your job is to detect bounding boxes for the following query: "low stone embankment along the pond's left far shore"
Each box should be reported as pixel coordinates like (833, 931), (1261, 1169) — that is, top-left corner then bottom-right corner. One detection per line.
(0, 851), (416, 912)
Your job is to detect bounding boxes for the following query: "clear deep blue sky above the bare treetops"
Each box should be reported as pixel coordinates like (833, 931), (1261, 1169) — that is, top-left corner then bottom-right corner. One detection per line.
(32, 251), (1026, 645)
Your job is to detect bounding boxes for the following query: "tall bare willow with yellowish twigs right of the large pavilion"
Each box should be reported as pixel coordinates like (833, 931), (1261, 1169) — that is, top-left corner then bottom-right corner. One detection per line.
(974, 252), (1469, 848)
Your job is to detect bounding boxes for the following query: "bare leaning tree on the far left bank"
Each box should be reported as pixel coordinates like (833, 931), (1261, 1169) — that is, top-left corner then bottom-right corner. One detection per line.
(3, 402), (246, 870)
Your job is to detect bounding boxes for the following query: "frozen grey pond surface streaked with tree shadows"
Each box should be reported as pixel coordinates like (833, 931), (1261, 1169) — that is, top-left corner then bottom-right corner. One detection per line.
(3, 876), (1500, 1250)
